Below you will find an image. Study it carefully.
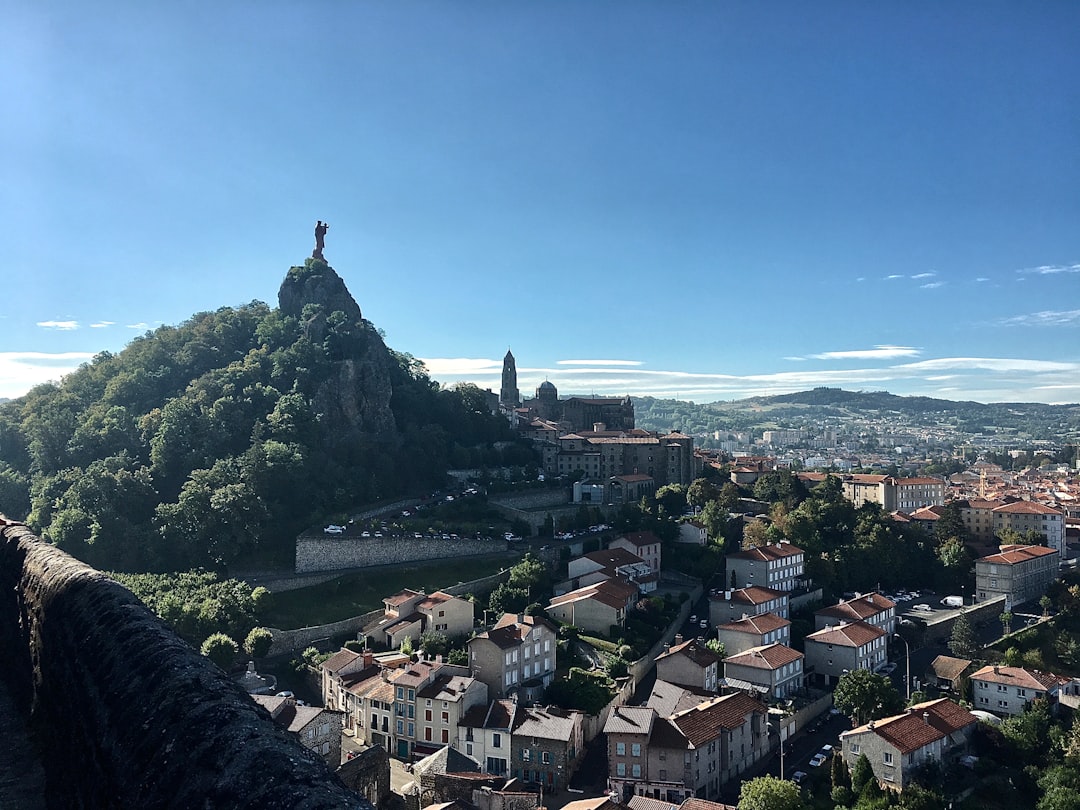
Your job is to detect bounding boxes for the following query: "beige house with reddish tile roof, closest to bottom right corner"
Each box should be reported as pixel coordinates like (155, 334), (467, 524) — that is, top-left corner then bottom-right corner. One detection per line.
(840, 698), (978, 791)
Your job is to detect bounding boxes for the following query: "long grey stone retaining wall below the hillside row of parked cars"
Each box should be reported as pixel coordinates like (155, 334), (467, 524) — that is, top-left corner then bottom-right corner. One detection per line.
(296, 535), (507, 573)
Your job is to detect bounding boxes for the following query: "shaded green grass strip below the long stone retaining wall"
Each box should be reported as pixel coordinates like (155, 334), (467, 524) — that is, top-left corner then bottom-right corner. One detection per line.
(262, 556), (516, 630)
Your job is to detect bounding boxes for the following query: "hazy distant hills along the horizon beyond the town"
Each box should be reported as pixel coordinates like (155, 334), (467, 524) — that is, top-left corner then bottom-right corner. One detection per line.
(634, 388), (1080, 443)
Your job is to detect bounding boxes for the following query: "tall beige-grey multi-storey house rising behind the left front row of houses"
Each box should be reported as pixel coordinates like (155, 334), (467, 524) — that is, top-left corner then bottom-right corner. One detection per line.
(468, 613), (556, 699)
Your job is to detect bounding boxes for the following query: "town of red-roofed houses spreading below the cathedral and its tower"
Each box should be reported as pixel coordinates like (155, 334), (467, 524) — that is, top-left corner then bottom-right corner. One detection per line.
(272, 375), (1080, 810)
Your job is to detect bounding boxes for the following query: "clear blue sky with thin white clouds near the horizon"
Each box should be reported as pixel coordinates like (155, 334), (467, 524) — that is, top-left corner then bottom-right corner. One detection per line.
(0, 0), (1080, 402)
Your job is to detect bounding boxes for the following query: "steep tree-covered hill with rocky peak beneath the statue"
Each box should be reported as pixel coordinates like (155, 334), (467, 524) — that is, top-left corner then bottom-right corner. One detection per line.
(0, 259), (514, 571)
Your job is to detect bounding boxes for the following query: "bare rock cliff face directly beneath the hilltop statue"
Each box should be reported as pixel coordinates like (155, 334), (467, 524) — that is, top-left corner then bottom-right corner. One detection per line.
(278, 258), (399, 444)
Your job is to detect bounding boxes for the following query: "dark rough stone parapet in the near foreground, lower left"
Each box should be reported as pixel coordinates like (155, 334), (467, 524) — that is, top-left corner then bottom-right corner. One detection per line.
(0, 519), (372, 810)
